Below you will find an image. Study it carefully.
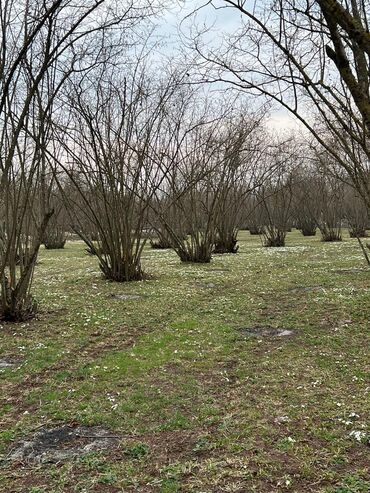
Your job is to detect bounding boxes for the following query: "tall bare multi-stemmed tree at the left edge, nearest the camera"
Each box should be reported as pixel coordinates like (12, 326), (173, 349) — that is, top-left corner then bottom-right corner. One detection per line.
(0, 0), (156, 320)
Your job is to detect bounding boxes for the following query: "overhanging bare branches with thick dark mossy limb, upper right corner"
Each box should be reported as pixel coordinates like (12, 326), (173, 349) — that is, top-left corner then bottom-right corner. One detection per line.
(191, 0), (370, 212)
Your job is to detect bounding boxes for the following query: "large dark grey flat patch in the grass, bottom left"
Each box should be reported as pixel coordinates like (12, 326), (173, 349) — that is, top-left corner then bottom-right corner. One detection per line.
(7, 425), (120, 463)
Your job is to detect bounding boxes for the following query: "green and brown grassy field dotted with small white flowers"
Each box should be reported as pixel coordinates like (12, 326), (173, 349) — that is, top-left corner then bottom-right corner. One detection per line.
(0, 231), (370, 493)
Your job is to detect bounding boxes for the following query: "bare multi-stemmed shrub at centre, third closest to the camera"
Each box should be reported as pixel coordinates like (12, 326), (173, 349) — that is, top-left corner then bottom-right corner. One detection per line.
(149, 91), (224, 263)
